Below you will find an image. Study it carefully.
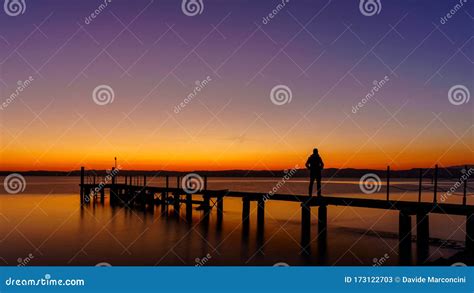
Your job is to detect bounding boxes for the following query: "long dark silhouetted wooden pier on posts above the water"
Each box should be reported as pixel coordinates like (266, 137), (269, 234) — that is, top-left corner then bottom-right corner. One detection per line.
(80, 167), (474, 264)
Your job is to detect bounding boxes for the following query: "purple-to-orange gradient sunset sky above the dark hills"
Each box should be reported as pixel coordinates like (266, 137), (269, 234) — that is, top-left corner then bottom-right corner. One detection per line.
(0, 0), (474, 170)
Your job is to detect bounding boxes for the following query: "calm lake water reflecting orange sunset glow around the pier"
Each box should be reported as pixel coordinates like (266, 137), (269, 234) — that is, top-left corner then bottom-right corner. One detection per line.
(0, 177), (474, 265)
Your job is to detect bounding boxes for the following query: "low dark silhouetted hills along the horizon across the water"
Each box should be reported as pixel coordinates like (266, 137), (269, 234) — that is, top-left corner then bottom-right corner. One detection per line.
(0, 164), (474, 178)
